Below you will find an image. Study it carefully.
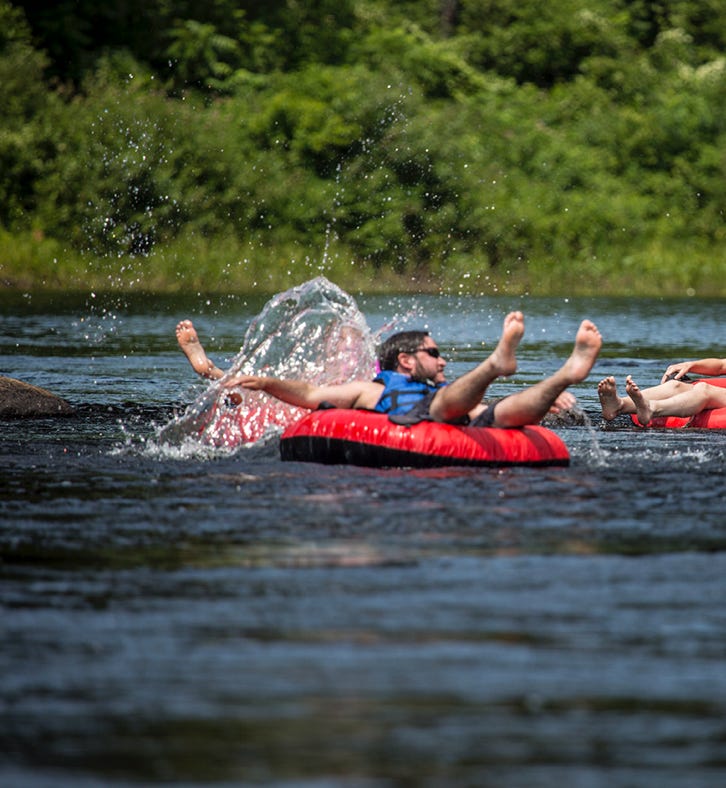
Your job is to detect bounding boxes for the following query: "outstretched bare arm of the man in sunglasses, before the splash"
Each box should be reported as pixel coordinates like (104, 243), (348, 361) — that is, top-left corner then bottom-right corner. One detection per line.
(223, 375), (383, 410)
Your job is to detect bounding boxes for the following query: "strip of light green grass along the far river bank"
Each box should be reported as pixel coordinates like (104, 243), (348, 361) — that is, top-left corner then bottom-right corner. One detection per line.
(0, 238), (726, 299)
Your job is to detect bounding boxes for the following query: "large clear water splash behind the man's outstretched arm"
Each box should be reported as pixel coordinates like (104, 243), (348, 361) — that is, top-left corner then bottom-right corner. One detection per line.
(158, 276), (376, 449)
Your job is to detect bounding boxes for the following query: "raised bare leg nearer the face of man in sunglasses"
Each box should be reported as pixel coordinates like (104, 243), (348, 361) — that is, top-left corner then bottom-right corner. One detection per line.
(430, 312), (524, 421)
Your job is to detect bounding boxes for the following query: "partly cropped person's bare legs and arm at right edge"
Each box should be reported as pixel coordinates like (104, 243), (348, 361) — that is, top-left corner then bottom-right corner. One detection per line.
(597, 358), (726, 427)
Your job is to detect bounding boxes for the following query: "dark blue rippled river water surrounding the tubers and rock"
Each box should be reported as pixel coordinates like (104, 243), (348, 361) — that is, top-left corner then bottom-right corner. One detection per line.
(0, 292), (726, 788)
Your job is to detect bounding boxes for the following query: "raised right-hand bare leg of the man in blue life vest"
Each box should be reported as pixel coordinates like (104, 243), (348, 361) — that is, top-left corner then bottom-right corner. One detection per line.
(494, 320), (602, 427)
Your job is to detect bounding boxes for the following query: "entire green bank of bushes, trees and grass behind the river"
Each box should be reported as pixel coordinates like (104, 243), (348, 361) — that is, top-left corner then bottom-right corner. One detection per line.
(0, 0), (726, 298)
